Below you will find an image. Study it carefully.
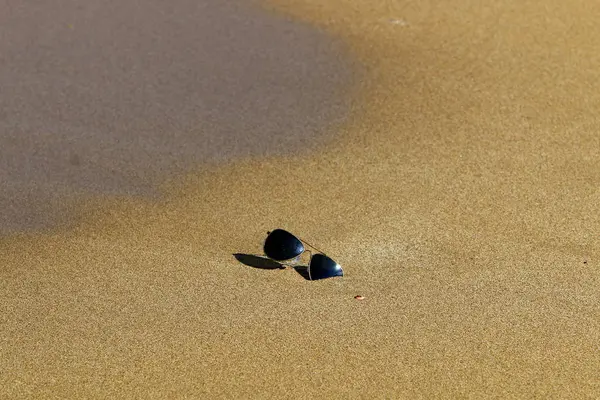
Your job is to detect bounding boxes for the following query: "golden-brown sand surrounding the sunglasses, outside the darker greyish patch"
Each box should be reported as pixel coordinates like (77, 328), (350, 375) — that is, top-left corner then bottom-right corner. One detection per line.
(0, 0), (600, 398)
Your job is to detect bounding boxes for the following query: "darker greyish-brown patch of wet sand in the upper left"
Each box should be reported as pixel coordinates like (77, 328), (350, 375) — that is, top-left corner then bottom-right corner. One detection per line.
(0, 0), (353, 233)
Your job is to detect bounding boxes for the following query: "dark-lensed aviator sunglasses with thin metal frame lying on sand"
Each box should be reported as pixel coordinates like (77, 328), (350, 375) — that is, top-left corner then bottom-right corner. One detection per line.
(264, 229), (344, 281)
